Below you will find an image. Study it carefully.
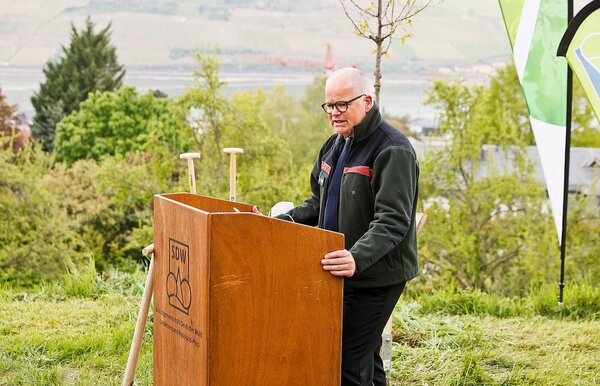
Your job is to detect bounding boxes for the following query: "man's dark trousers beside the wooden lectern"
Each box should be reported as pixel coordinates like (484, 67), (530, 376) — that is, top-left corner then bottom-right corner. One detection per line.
(342, 283), (406, 386)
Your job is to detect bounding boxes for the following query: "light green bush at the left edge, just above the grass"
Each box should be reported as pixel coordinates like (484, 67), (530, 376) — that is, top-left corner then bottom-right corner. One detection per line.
(0, 142), (85, 286)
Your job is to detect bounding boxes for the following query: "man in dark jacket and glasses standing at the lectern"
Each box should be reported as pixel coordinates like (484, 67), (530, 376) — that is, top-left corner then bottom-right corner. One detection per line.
(280, 68), (419, 386)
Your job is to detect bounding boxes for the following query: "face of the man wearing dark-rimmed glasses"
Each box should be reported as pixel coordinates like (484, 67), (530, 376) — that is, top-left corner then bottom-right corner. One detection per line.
(325, 75), (373, 137)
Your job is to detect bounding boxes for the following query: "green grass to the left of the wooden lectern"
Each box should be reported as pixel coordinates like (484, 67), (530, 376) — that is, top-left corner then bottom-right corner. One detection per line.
(0, 271), (152, 385)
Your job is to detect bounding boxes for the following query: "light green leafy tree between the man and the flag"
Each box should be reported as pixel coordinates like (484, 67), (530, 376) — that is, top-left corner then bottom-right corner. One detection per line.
(421, 70), (558, 294)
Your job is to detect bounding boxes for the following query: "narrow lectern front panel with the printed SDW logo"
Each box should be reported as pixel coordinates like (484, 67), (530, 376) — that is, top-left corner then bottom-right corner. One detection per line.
(154, 196), (209, 386)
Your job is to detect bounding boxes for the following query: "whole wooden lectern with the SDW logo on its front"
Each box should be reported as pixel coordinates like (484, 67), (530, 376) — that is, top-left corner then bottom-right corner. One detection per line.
(153, 193), (344, 386)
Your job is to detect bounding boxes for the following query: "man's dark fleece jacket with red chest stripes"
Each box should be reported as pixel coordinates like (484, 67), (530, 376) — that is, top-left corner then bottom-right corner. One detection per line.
(280, 105), (419, 288)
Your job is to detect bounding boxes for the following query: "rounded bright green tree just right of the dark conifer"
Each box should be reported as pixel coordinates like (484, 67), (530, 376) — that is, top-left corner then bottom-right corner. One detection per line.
(55, 87), (192, 164)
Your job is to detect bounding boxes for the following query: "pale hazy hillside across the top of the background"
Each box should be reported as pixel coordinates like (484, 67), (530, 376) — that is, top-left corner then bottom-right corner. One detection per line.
(0, 0), (510, 73)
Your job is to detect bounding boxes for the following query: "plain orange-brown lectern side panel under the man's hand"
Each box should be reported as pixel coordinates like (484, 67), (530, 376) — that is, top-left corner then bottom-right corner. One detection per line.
(209, 213), (344, 386)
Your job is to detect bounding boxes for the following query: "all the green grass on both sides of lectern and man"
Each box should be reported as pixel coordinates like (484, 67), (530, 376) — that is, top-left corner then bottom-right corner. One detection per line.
(0, 265), (600, 386)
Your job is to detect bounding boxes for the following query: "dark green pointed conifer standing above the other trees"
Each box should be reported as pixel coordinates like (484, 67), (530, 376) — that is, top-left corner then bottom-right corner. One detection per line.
(31, 18), (125, 151)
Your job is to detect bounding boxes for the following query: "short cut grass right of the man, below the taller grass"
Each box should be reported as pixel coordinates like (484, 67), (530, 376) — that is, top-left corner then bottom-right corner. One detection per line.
(392, 303), (600, 385)
